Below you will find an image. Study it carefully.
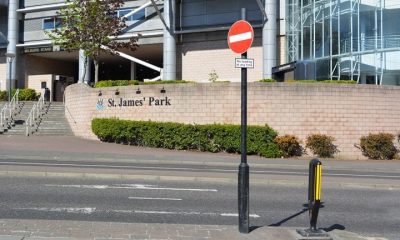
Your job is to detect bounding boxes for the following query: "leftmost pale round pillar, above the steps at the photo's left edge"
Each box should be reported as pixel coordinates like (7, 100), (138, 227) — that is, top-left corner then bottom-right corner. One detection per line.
(7, 0), (19, 88)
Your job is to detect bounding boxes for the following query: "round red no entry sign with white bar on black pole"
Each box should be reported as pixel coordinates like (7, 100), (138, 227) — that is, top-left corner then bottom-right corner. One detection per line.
(228, 20), (254, 54)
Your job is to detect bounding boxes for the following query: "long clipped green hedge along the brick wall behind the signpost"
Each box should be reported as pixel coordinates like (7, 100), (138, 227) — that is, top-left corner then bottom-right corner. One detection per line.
(92, 118), (281, 158)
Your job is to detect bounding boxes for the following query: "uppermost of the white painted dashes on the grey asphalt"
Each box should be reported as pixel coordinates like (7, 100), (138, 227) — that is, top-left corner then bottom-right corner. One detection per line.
(45, 184), (218, 192)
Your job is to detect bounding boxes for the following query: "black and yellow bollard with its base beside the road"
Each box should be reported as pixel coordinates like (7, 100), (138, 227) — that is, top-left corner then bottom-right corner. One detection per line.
(297, 159), (331, 239)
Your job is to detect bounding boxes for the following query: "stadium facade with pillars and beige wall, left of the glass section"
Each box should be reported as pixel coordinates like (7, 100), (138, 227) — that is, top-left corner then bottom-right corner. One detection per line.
(0, 0), (285, 99)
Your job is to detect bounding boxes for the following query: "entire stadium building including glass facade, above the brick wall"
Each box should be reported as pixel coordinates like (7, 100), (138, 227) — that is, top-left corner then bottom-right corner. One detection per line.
(0, 0), (400, 100)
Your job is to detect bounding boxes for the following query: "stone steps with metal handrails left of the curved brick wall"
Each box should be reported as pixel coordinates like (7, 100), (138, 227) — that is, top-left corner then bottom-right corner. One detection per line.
(0, 102), (73, 136)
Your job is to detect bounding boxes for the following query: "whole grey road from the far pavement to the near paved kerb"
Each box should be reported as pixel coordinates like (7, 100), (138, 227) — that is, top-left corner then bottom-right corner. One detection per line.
(0, 158), (400, 240)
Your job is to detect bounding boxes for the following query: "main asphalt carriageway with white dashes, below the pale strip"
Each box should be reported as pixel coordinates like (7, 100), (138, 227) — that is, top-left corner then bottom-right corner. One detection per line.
(0, 174), (400, 240)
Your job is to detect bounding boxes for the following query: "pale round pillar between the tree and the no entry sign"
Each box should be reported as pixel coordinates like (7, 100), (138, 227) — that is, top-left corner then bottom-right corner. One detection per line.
(162, 0), (176, 80)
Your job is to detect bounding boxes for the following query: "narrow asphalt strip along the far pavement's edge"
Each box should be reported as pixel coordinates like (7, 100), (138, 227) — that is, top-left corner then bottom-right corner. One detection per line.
(0, 158), (400, 180)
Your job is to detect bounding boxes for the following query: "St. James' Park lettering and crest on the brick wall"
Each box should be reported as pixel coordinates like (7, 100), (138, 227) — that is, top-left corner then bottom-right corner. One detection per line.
(96, 97), (171, 110)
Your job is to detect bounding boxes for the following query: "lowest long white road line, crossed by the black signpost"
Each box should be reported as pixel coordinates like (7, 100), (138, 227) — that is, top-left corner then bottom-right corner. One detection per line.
(15, 208), (260, 218)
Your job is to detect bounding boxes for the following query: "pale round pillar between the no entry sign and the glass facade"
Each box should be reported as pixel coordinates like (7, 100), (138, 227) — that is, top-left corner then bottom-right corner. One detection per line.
(262, 0), (278, 78)
